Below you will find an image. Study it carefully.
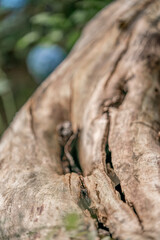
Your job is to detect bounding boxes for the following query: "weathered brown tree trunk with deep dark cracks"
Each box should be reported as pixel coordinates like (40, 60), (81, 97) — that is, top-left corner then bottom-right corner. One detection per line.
(0, 0), (160, 240)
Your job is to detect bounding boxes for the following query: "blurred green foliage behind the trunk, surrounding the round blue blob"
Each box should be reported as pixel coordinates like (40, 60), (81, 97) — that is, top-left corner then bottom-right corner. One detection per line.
(0, 0), (112, 133)
